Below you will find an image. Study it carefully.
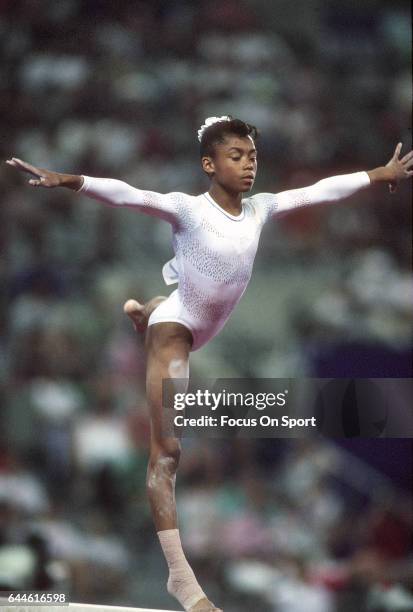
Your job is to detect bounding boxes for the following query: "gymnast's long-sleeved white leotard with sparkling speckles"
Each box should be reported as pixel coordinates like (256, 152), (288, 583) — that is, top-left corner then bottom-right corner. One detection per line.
(79, 172), (370, 351)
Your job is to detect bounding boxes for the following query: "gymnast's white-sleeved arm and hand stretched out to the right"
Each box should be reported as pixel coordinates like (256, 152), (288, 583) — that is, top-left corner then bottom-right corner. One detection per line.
(255, 143), (413, 216)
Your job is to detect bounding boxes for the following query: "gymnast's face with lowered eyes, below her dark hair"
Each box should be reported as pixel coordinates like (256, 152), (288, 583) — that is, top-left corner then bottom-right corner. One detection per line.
(202, 134), (257, 193)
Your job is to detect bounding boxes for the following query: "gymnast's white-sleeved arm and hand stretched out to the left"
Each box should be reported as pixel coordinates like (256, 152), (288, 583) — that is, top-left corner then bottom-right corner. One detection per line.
(6, 157), (184, 225)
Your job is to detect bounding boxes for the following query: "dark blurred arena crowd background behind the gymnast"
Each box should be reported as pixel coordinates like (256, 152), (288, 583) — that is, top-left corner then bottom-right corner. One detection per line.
(0, 0), (413, 612)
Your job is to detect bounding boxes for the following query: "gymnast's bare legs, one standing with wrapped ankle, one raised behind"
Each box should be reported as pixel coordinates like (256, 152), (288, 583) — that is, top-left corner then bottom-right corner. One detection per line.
(124, 297), (221, 612)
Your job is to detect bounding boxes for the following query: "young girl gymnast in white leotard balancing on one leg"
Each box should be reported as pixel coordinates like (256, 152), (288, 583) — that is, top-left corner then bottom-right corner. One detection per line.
(7, 116), (413, 612)
